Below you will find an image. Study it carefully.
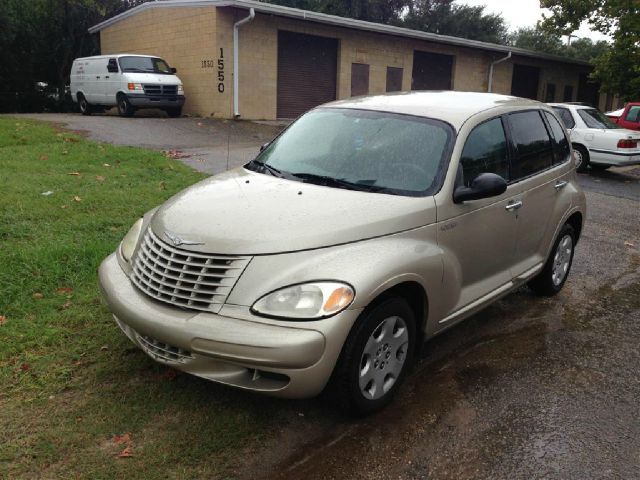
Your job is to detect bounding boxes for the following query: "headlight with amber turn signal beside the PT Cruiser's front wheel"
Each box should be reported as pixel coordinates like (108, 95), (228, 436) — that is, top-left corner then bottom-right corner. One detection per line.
(251, 282), (355, 320)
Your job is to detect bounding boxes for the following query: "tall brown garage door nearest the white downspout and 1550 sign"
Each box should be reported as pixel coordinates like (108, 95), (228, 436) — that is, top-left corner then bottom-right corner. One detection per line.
(277, 30), (338, 118)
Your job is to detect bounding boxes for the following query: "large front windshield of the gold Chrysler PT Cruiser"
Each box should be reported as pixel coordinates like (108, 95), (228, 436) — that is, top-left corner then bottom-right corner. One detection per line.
(246, 108), (453, 196)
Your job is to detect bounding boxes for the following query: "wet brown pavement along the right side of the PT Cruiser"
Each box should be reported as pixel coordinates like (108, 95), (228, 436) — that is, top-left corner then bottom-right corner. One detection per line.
(235, 168), (640, 480)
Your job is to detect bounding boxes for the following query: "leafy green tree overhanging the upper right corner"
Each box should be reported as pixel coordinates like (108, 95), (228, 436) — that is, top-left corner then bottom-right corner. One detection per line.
(540, 0), (640, 100)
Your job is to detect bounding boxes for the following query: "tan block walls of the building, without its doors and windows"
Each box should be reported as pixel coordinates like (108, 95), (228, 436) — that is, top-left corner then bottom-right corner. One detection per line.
(101, 7), (587, 120)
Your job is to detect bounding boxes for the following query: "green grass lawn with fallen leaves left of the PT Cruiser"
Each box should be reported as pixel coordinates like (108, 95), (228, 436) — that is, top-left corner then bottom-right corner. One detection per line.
(0, 118), (284, 479)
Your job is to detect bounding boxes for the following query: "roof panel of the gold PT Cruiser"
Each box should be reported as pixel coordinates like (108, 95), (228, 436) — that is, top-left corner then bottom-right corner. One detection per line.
(318, 90), (544, 128)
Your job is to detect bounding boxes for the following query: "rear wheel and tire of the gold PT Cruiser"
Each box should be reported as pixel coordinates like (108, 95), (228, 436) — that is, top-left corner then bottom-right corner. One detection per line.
(529, 223), (577, 297)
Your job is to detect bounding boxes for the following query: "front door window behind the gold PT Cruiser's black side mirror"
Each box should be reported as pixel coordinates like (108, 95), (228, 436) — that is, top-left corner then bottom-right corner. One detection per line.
(460, 118), (509, 187)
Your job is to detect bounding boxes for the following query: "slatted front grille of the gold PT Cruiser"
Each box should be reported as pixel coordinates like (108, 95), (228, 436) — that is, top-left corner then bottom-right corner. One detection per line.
(131, 228), (251, 312)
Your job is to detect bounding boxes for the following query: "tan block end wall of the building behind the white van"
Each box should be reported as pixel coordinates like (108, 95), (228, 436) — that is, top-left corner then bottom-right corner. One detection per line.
(100, 7), (217, 116)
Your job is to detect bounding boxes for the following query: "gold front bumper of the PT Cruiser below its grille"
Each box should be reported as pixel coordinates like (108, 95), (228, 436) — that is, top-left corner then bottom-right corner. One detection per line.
(99, 254), (361, 398)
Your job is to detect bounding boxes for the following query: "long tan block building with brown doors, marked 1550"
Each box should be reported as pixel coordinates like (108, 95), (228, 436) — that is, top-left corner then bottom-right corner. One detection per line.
(90, 0), (606, 120)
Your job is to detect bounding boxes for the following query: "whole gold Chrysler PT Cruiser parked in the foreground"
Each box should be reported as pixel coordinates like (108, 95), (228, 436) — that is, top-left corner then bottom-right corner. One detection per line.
(100, 92), (585, 414)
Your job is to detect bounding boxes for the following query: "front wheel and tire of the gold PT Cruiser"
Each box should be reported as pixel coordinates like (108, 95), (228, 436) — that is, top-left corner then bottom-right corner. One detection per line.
(329, 297), (416, 416)
